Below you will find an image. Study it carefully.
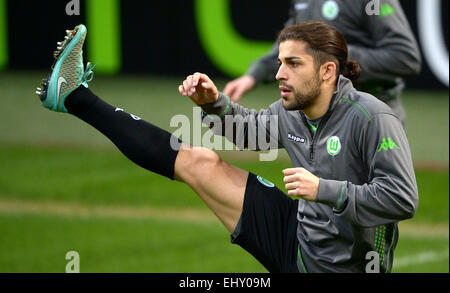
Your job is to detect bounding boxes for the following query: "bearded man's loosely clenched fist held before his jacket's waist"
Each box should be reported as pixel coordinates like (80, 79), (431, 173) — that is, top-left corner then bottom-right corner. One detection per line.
(283, 168), (320, 201)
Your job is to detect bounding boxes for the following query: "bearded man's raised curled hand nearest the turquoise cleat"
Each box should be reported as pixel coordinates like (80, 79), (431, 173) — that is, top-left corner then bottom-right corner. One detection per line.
(178, 72), (219, 106)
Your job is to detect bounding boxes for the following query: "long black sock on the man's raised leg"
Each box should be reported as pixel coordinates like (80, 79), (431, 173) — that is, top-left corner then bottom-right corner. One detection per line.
(64, 86), (181, 179)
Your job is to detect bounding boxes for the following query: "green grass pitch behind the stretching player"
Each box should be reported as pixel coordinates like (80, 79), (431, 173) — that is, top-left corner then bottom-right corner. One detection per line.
(0, 72), (449, 273)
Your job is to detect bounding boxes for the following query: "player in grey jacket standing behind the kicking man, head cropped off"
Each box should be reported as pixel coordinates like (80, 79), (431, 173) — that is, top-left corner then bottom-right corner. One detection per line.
(224, 0), (422, 127)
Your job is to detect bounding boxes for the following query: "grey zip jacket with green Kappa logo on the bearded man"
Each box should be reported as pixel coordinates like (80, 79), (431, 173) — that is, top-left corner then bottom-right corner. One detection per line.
(202, 76), (418, 272)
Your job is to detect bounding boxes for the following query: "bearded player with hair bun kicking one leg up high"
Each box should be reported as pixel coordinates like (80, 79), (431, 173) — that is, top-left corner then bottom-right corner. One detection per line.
(37, 22), (418, 272)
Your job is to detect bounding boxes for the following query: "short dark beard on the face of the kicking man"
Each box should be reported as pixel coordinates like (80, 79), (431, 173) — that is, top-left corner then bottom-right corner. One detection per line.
(280, 73), (321, 111)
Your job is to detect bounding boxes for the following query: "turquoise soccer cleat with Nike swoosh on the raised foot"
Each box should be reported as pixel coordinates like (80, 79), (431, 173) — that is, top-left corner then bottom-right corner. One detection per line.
(36, 24), (95, 113)
